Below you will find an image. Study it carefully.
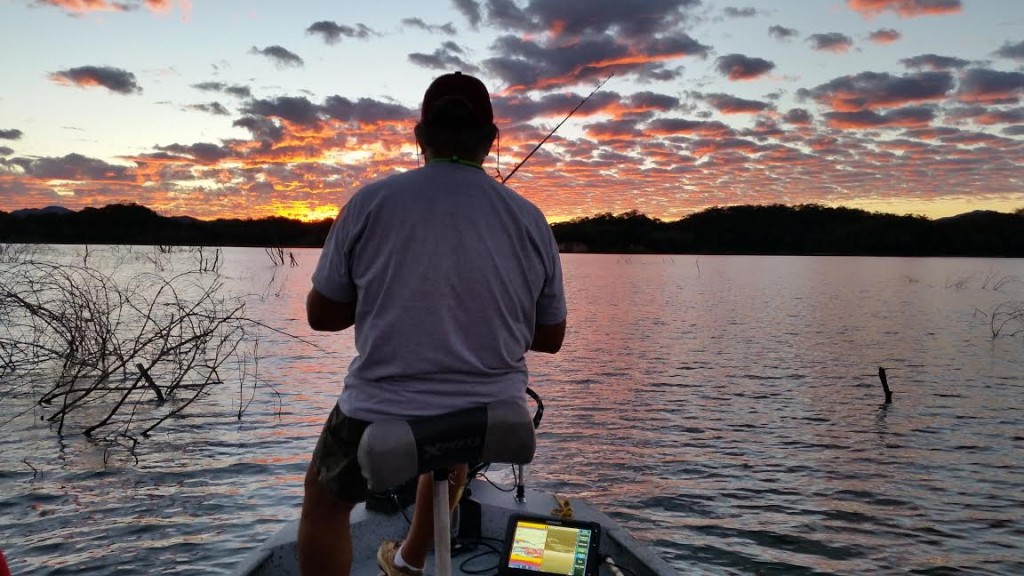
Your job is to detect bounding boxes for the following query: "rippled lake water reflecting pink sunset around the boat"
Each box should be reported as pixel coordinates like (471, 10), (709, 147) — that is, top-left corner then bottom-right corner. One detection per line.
(0, 247), (1024, 575)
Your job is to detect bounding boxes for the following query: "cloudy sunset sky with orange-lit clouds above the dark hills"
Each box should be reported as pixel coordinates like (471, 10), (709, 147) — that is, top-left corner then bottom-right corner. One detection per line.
(0, 0), (1024, 221)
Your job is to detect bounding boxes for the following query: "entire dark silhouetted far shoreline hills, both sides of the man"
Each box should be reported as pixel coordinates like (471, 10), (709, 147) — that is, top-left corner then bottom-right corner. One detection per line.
(0, 204), (1024, 257)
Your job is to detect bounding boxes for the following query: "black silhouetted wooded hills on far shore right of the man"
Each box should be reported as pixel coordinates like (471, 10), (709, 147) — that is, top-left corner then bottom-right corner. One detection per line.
(552, 204), (1024, 257)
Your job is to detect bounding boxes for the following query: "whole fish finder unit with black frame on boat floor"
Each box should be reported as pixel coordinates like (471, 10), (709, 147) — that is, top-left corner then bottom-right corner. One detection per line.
(498, 515), (601, 576)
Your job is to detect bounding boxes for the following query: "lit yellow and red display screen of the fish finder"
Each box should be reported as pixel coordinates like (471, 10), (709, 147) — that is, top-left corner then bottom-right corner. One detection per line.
(508, 521), (594, 576)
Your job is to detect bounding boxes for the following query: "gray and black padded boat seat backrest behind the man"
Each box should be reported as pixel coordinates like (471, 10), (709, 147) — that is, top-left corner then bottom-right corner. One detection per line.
(358, 402), (537, 492)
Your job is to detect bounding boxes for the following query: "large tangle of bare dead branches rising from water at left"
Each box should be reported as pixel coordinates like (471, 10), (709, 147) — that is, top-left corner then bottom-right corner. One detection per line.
(0, 258), (290, 443)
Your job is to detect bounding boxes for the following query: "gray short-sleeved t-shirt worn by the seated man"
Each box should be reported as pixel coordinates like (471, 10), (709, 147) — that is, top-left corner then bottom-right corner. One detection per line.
(312, 162), (566, 421)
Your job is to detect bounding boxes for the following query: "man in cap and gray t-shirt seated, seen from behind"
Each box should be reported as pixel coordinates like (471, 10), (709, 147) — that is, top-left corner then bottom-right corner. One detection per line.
(298, 72), (566, 576)
